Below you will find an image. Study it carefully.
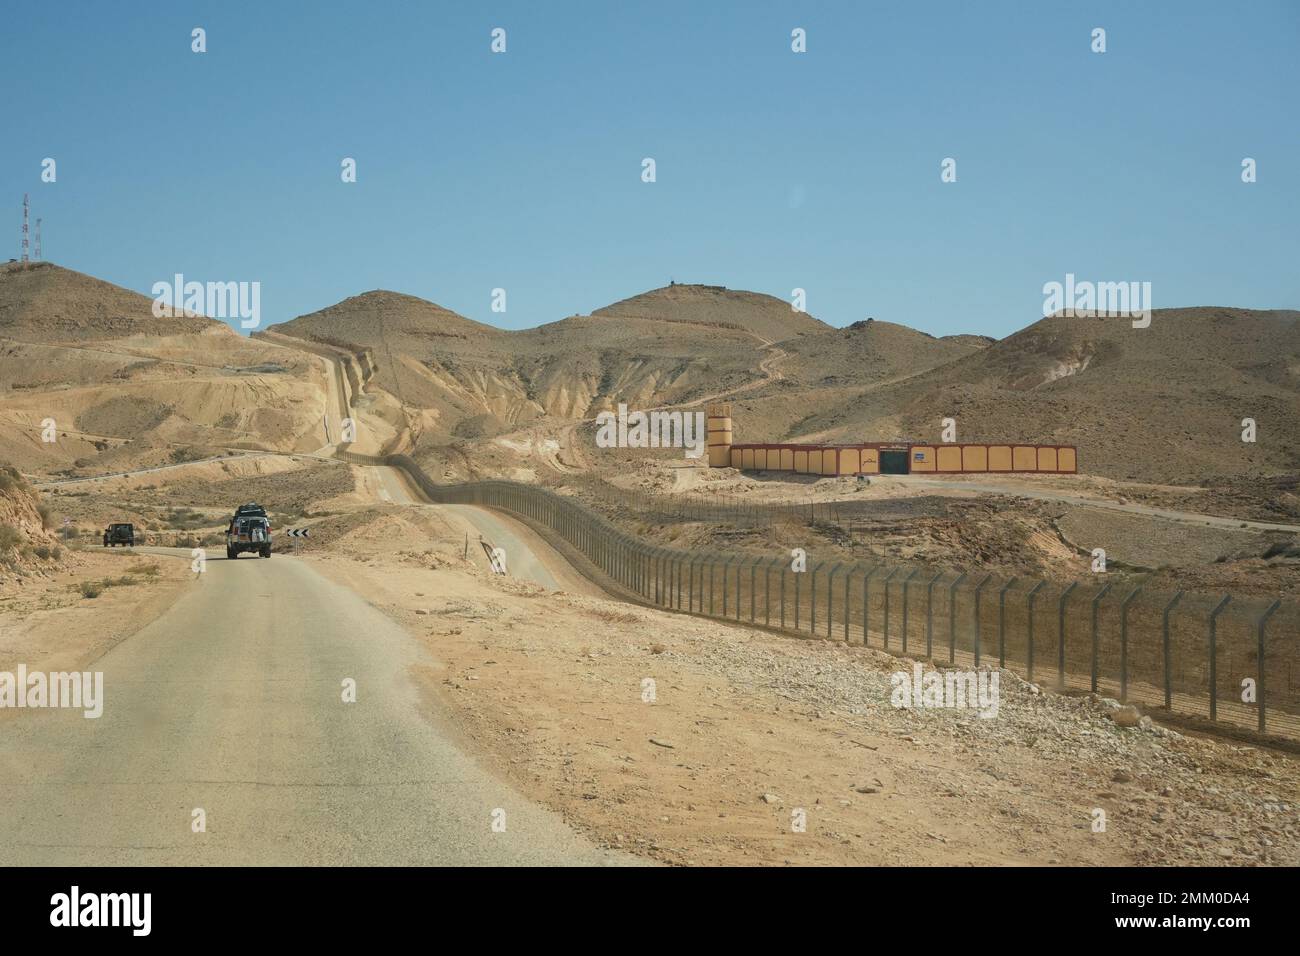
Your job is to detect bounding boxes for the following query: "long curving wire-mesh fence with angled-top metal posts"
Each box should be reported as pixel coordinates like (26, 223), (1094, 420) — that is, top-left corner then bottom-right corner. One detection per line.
(338, 451), (1300, 739)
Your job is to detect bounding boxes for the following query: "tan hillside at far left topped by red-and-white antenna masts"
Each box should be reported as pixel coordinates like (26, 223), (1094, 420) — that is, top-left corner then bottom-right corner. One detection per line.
(0, 263), (340, 473)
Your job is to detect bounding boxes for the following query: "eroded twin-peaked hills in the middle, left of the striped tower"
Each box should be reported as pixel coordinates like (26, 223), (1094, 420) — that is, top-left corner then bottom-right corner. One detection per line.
(274, 278), (829, 442)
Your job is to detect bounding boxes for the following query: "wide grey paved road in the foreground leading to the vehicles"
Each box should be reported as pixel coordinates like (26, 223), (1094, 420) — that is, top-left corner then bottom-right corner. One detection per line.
(0, 549), (631, 865)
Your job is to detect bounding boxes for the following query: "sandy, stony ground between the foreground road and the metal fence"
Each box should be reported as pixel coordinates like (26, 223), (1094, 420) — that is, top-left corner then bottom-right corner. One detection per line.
(306, 509), (1300, 865)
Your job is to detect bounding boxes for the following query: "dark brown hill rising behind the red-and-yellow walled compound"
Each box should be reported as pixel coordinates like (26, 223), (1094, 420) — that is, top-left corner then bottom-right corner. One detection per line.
(784, 308), (1300, 481)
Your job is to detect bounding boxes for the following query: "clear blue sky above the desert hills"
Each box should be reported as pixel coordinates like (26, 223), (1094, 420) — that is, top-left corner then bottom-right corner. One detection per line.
(0, 0), (1300, 336)
